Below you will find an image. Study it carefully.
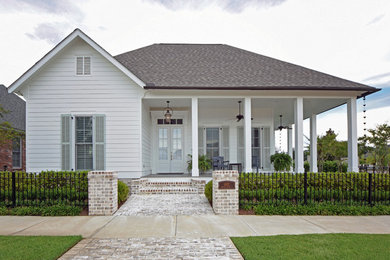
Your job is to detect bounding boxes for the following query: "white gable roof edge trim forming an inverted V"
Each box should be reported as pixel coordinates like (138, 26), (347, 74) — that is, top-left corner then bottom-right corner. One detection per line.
(8, 28), (145, 93)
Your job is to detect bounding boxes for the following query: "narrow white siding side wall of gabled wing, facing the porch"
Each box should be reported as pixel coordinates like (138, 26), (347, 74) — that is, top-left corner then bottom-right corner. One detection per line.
(142, 100), (152, 175)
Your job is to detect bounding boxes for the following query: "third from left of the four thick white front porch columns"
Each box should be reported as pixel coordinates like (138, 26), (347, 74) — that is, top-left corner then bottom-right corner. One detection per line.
(294, 97), (305, 173)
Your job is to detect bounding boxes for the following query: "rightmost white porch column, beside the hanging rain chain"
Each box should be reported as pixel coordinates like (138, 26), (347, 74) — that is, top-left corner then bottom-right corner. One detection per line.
(347, 97), (359, 172)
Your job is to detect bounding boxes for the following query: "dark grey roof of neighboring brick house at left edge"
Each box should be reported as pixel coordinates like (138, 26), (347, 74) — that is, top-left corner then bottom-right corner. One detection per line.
(0, 85), (26, 131)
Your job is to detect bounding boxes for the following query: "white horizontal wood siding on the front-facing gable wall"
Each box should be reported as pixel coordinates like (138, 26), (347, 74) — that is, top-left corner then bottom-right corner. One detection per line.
(22, 39), (143, 177)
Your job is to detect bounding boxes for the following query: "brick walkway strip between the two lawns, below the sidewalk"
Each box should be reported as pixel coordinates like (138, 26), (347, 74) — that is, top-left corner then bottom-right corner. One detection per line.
(60, 238), (243, 260)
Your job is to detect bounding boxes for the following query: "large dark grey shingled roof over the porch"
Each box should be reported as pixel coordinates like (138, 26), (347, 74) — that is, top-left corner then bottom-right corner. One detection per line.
(115, 44), (379, 93)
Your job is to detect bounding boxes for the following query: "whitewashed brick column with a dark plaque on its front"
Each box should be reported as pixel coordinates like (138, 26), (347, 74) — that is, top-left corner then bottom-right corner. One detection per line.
(213, 171), (239, 215)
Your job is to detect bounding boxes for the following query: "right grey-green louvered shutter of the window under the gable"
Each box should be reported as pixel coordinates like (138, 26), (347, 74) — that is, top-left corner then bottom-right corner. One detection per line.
(95, 115), (106, 170)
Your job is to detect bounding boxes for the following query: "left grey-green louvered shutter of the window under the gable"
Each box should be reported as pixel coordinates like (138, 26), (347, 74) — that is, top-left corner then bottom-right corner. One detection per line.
(61, 115), (72, 170)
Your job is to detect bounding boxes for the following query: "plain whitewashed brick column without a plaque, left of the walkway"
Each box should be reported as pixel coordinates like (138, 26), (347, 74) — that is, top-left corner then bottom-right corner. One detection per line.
(88, 171), (118, 216)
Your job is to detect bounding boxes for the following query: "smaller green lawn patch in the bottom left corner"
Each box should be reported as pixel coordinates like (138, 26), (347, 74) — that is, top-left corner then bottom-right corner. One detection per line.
(0, 236), (81, 260)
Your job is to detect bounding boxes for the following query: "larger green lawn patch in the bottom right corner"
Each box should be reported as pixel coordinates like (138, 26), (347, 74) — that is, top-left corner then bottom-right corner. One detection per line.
(231, 234), (390, 260)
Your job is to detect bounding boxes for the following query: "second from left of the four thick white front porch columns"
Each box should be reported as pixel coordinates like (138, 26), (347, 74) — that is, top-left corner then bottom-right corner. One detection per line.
(244, 98), (252, 172)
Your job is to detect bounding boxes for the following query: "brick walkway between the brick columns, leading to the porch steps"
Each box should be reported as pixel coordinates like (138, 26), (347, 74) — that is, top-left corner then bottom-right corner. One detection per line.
(115, 194), (214, 216)
